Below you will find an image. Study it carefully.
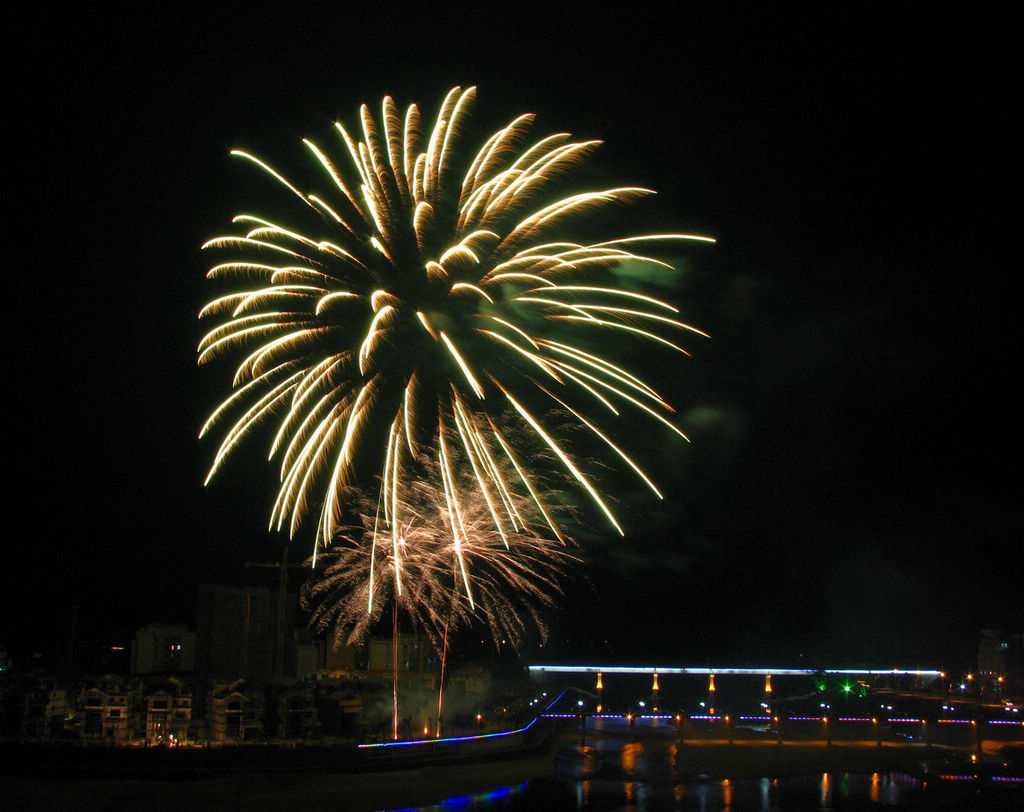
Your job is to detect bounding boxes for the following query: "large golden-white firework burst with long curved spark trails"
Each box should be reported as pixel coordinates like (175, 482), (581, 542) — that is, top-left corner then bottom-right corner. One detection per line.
(199, 87), (713, 581)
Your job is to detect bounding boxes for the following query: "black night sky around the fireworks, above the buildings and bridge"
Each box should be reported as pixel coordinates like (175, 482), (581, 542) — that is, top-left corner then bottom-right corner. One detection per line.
(6, 3), (1024, 666)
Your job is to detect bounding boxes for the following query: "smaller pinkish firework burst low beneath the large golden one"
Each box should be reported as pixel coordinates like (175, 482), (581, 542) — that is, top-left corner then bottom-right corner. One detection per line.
(303, 444), (578, 651)
